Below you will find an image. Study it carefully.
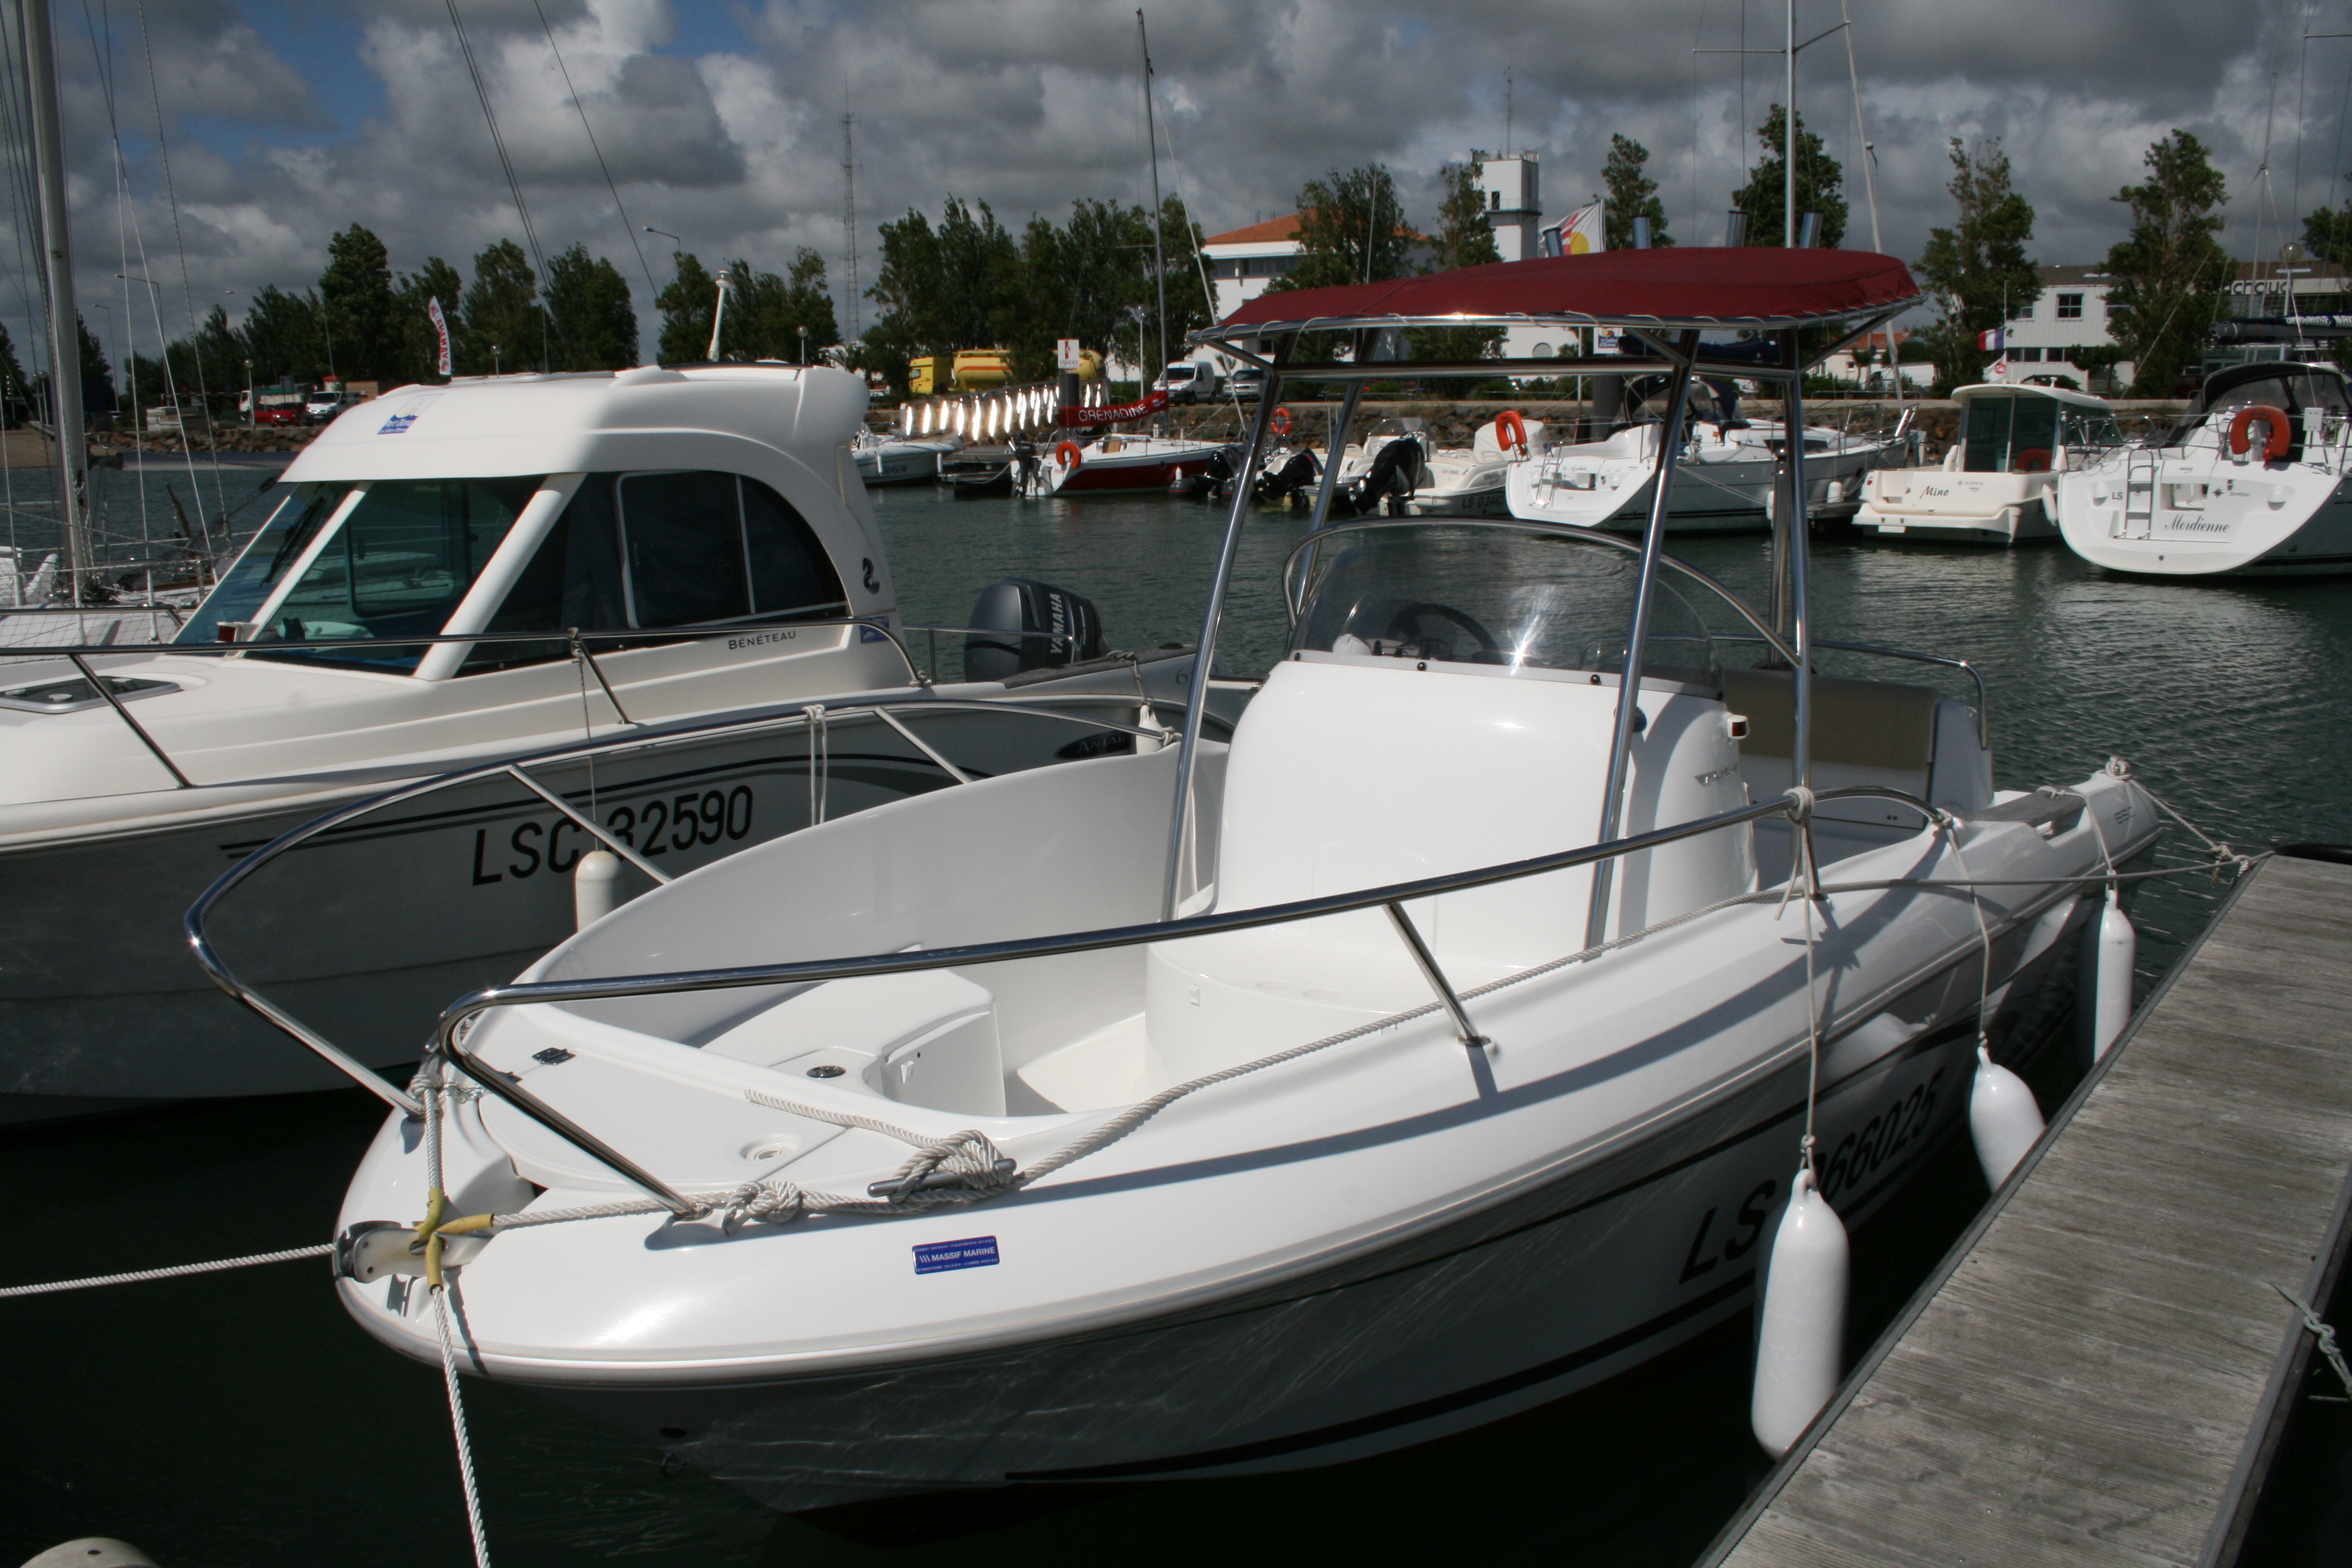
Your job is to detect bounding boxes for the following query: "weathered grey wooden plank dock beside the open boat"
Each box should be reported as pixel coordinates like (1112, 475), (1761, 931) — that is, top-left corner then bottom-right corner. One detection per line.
(1700, 858), (2352, 1568)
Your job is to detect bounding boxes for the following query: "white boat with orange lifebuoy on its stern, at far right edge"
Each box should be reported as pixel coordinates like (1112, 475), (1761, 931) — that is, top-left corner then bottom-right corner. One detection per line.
(2058, 362), (2352, 576)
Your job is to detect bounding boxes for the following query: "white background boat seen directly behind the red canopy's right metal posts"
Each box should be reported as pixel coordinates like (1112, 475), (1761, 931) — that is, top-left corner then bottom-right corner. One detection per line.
(1508, 399), (1907, 534)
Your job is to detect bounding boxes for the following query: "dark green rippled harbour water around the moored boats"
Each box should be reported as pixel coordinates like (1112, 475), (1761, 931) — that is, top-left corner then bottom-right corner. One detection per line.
(0, 475), (2352, 1568)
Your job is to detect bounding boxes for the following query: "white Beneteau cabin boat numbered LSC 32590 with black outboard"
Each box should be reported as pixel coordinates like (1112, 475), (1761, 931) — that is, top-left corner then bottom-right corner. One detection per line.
(0, 364), (1232, 1119)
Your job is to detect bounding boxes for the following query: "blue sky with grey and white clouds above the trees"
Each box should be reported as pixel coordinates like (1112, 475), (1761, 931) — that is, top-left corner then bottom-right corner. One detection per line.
(0, 0), (2352, 378)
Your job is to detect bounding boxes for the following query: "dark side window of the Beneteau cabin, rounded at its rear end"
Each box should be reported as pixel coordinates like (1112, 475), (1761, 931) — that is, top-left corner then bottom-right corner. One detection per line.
(461, 470), (849, 675)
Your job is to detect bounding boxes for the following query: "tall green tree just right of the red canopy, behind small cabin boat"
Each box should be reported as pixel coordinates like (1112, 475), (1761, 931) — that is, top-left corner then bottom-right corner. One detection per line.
(1919, 136), (2042, 395)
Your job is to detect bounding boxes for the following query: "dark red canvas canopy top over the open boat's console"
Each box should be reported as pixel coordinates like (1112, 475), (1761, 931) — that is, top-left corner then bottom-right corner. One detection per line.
(1195, 244), (1919, 341)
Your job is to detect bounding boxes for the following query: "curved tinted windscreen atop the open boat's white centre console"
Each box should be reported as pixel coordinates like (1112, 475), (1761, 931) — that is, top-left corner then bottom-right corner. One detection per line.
(1292, 522), (1722, 689)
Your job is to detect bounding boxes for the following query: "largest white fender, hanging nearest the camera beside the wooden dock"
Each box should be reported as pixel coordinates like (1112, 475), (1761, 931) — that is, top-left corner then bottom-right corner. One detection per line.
(1748, 1168), (1849, 1457)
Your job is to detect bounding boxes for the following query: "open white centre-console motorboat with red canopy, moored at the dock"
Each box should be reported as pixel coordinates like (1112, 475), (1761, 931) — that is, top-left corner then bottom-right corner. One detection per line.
(322, 249), (2154, 1509)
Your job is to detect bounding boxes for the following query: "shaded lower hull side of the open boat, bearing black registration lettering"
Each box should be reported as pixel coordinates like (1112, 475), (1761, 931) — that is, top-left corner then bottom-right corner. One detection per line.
(541, 900), (2082, 1512)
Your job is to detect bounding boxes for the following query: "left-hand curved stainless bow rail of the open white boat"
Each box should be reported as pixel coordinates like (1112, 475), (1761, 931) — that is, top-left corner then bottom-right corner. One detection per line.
(181, 691), (1162, 1117)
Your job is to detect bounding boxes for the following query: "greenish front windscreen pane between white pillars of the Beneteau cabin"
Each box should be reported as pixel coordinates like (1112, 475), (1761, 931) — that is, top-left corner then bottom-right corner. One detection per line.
(240, 477), (541, 670)
